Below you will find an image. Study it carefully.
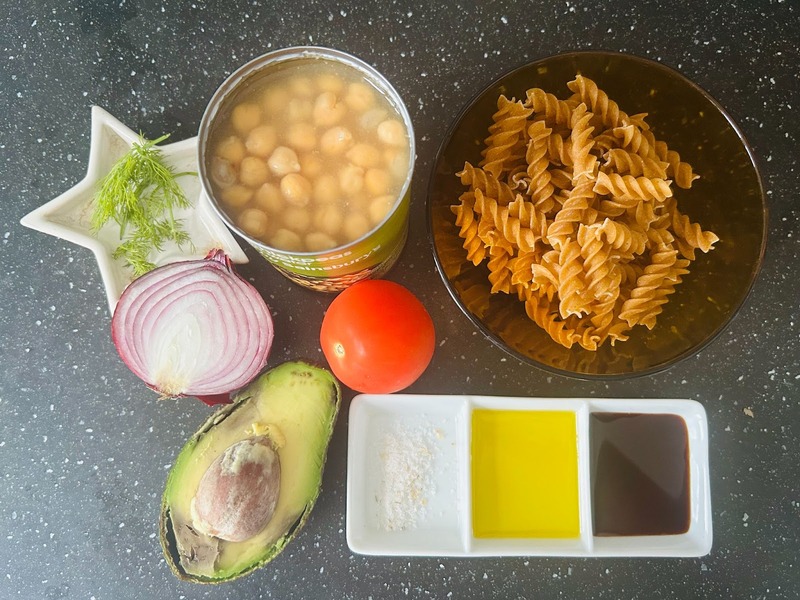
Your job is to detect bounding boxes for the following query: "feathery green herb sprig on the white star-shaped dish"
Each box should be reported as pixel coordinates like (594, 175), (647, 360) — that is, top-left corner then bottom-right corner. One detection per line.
(91, 134), (194, 277)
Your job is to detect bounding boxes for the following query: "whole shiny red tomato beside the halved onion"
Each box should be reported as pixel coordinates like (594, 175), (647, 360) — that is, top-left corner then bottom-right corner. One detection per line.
(320, 279), (436, 394)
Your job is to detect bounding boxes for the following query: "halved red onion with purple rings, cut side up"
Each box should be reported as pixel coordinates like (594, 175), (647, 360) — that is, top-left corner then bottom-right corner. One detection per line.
(111, 250), (274, 403)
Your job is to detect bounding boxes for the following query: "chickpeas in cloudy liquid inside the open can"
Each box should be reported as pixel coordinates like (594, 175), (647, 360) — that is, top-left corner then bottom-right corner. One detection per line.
(207, 59), (411, 252)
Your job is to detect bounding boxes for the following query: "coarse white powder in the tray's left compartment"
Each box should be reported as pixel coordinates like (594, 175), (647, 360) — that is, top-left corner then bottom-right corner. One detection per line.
(376, 425), (442, 531)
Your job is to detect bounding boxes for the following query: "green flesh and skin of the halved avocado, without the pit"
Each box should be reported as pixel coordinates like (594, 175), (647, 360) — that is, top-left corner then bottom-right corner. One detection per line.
(160, 362), (341, 583)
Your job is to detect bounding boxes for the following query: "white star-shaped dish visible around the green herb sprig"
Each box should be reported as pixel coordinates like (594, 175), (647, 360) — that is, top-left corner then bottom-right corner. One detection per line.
(21, 106), (248, 314)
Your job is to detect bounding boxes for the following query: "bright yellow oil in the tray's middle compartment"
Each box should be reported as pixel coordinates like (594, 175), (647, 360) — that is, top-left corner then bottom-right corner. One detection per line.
(471, 409), (580, 538)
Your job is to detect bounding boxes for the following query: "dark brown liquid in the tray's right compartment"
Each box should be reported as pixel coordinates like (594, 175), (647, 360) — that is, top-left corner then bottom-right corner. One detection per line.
(590, 413), (691, 536)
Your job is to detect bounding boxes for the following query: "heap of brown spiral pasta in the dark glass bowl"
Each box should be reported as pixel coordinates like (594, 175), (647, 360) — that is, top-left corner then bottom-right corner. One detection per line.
(451, 74), (719, 350)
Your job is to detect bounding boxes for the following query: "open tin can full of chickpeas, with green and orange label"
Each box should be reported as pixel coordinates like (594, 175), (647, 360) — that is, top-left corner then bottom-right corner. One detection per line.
(198, 47), (414, 291)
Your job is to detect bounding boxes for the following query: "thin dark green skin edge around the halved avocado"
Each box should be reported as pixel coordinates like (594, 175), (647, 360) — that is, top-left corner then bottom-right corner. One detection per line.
(159, 361), (342, 584)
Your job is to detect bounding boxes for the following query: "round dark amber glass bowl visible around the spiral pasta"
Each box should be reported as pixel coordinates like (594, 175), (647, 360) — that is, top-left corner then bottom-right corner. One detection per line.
(427, 51), (767, 379)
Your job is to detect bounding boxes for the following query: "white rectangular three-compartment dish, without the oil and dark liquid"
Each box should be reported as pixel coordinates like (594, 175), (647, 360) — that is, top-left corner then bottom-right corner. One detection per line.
(347, 394), (712, 557)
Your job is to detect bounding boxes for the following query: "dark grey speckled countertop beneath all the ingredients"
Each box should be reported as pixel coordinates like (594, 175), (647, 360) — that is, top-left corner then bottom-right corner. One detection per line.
(0, 0), (800, 600)
